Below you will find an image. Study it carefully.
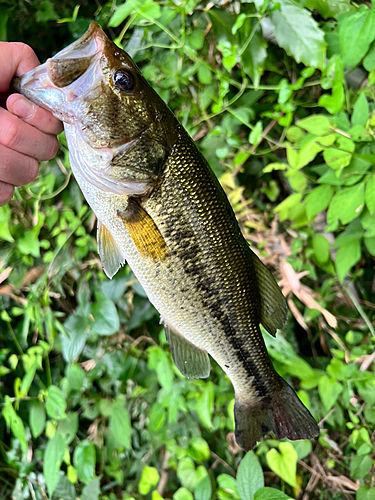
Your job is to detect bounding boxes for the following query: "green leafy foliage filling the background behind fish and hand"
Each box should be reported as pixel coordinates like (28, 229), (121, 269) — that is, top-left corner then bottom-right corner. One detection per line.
(0, 0), (375, 500)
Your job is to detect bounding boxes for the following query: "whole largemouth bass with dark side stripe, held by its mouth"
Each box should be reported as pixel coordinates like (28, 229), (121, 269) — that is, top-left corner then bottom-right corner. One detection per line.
(13, 22), (319, 450)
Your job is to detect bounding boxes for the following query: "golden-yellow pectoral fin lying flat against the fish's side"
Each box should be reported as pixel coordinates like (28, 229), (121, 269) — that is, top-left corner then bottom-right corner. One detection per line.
(118, 198), (168, 262)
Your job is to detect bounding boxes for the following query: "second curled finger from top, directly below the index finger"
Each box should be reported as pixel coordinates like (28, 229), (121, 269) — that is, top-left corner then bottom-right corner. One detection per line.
(0, 108), (58, 161)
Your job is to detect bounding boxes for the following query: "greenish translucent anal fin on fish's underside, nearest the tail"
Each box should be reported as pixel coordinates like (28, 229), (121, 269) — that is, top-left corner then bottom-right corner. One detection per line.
(164, 325), (210, 378)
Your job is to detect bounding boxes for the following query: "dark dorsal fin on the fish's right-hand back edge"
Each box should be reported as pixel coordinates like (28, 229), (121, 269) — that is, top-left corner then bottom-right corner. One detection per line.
(250, 250), (288, 337)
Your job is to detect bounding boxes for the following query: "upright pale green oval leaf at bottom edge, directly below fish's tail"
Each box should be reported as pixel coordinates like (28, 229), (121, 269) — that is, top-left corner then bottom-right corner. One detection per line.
(237, 451), (264, 500)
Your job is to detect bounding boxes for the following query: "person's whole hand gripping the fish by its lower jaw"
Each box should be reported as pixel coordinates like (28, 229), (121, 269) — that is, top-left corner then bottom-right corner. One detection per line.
(0, 42), (63, 206)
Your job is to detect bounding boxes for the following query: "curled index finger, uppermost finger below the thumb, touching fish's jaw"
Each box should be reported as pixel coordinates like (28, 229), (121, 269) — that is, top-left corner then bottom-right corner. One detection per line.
(7, 94), (64, 135)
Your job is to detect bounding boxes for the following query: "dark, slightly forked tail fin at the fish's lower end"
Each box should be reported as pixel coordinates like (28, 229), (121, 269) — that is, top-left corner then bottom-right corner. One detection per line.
(234, 379), (319, 451)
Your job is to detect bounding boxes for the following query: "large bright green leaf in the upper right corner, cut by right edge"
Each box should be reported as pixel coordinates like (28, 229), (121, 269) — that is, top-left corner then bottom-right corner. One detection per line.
(338, 5), (375, 68)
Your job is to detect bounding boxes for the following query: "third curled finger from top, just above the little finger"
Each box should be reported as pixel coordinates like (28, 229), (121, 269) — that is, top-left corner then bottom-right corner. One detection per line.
(0, 145), (38, 186)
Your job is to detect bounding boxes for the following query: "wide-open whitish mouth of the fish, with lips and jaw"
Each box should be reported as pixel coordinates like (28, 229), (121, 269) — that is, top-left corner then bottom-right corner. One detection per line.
(12, 22), (108, 124)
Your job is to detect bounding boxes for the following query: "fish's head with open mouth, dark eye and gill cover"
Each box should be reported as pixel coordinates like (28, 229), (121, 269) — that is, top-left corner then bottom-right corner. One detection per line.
(13, 22), (173, 194)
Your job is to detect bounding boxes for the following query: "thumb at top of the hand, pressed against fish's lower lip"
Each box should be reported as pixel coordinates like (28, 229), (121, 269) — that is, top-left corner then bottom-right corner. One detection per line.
(0, 42), (40, 92)
